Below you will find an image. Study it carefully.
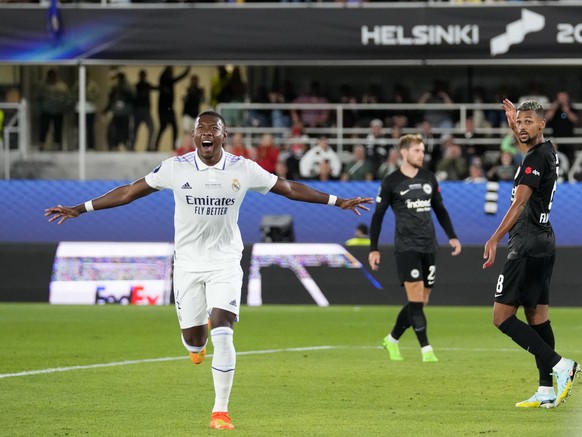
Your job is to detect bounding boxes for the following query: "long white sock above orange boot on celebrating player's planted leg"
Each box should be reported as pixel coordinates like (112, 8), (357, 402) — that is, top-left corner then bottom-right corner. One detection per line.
(210, 326), (236, 413)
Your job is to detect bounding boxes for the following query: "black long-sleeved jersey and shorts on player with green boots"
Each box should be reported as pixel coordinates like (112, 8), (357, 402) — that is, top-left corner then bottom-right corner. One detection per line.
(370, 169), (457, 287)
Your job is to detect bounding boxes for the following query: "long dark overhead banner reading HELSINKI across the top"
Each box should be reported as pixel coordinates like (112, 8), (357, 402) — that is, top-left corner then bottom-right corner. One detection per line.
(0, 2), (582, 65)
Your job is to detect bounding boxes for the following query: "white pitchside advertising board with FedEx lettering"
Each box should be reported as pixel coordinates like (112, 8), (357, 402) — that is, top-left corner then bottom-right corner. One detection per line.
(49, 242), (173, 305)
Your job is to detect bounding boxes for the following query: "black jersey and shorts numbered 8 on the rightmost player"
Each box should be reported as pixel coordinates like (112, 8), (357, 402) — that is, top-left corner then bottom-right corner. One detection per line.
(495, 141), (559, 307)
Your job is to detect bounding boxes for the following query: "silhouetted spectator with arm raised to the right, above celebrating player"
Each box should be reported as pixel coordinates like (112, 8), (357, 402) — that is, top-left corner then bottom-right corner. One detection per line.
(155, 65), (190, 150)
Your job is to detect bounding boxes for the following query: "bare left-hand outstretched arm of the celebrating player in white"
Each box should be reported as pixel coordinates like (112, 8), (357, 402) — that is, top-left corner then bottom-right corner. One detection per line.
(44, 178), (157, 225)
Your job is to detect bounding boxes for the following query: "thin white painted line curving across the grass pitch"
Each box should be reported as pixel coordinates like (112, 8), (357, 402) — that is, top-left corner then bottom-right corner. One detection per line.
(0, 346), (572, 379)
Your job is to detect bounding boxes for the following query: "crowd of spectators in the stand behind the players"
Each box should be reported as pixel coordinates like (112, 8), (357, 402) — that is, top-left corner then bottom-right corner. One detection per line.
(25, 62), (579, 182)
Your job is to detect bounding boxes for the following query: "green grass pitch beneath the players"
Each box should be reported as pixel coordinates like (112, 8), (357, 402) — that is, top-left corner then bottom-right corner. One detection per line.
(0, 304), (582, 437)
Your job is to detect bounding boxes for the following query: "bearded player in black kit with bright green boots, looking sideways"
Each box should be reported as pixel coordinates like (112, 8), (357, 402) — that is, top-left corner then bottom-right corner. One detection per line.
(368, 135), (461, 362)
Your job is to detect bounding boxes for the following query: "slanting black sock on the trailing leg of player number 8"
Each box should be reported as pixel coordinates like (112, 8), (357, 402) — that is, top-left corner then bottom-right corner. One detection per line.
(499, 315), (562, 367)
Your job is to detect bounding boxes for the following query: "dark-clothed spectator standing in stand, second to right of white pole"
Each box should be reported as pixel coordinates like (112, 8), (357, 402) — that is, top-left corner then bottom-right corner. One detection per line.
(103, 72), (135, 151)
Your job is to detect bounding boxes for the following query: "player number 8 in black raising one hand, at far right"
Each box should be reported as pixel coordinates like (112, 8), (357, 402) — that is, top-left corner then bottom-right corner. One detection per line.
(483, 99), (580, 408)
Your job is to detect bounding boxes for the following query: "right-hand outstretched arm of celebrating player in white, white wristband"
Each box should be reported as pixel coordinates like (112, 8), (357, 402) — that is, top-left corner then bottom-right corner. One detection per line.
(271, 178), (373, 215)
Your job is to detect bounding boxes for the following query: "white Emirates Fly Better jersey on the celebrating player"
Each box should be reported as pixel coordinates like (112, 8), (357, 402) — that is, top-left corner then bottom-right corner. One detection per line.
(145, 151), (277, 272)
